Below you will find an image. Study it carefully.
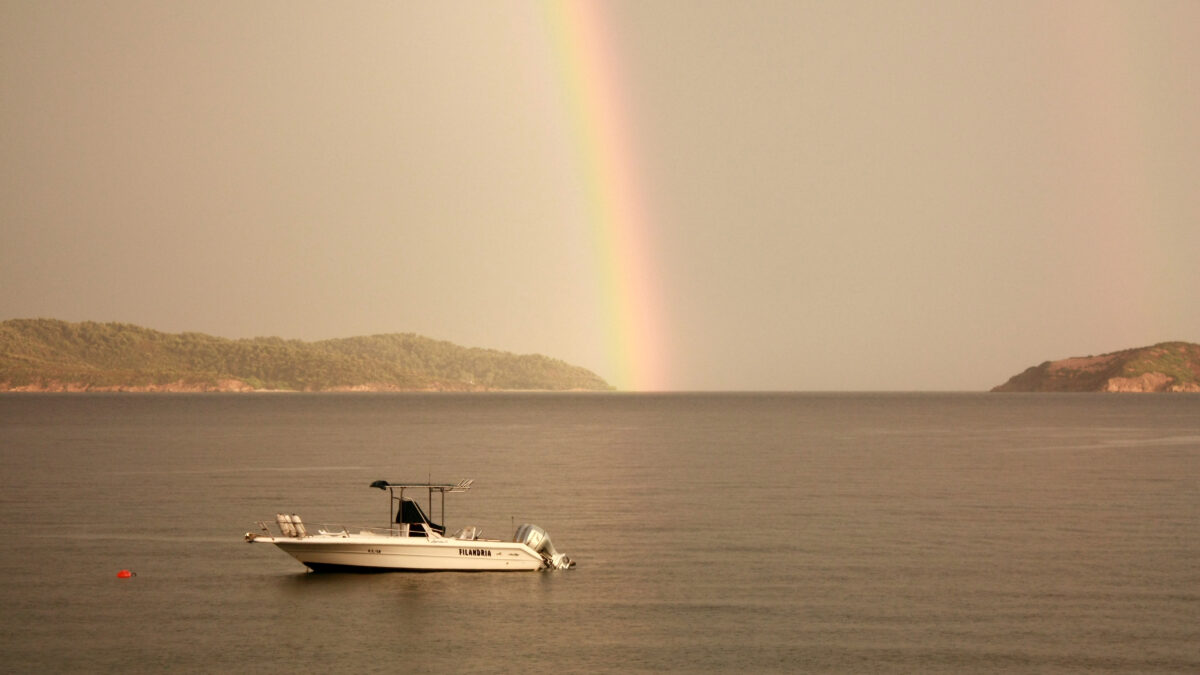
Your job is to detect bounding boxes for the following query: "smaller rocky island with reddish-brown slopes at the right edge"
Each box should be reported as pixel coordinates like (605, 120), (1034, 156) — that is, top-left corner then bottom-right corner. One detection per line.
(992, 342), (1200, 392)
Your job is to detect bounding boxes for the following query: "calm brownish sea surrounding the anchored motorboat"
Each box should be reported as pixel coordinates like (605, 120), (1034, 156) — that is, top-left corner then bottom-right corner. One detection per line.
(0, 393), (1200, 673)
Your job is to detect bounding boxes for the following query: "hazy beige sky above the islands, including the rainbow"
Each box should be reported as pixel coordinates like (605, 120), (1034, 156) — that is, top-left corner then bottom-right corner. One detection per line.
(0, 0), (1200, 390)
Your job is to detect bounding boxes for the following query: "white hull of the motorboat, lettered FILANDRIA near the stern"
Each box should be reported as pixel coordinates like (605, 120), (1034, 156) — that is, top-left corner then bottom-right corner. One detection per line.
(254, 534), (546, 572)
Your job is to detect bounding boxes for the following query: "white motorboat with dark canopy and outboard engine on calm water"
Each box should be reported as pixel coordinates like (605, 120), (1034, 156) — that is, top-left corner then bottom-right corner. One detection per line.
(246, 480), (575, 572)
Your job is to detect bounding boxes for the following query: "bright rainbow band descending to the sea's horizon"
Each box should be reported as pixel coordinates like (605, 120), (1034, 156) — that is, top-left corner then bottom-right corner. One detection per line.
(542, 0), (666, 390)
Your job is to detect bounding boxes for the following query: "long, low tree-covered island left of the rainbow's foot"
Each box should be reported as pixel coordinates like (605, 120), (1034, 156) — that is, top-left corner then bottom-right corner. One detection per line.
(0, 318), (612, 392)
